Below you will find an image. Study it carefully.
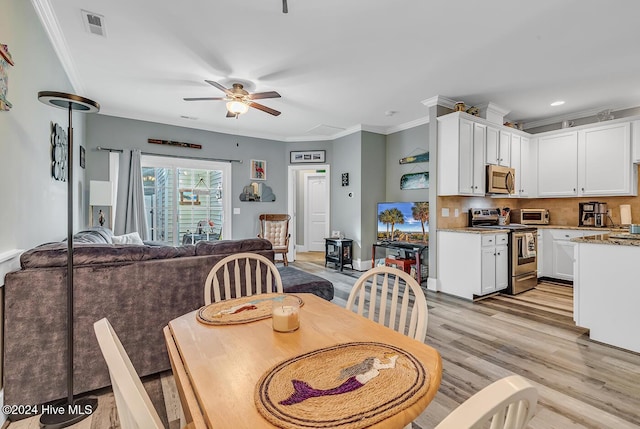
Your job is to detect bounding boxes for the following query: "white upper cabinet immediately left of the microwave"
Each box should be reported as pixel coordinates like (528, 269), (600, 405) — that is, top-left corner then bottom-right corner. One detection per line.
(437, 113), (487, 195)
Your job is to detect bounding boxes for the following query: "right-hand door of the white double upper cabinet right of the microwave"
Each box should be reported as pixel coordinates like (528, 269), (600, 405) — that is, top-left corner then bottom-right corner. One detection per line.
(578, 122), (637, 196)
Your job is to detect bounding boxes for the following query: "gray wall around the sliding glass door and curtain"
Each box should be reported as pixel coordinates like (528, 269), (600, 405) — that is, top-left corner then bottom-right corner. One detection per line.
(87, 115), (289, 239)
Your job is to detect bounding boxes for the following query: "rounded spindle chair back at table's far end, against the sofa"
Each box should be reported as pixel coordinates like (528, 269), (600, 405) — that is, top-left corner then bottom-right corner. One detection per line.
(204, 252), (284, 305)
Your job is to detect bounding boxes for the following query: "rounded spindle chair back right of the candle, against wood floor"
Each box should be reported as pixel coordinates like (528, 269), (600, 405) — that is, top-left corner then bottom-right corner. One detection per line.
(346, 266), (428, 342)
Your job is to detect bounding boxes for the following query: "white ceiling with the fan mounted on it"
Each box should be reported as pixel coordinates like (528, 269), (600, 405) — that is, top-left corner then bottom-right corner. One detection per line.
(32, 0), (640, 141)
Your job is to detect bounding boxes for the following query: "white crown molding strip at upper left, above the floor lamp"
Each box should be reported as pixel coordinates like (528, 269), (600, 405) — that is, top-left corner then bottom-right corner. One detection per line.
(31, 0), (85, 94)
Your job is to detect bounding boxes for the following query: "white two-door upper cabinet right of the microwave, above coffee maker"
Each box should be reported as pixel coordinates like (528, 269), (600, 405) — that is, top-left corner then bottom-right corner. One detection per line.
(537, 121), (637, 197)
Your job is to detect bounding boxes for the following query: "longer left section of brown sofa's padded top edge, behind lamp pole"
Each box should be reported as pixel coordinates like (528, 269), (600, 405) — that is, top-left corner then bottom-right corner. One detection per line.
(20, 243), (195, 269)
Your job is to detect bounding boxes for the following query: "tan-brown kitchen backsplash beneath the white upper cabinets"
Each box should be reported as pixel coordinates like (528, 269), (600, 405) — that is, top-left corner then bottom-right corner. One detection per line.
(438, 166), (640, 228)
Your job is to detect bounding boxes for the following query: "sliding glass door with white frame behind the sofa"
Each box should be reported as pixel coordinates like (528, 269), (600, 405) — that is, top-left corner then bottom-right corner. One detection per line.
(141, 155), (231, 246)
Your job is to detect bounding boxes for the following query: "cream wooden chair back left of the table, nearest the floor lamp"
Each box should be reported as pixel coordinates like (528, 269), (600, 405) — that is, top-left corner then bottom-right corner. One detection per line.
(93, 318), (164, 429)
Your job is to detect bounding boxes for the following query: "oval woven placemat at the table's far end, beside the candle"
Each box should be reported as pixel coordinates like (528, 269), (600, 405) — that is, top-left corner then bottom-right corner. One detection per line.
(196, 293), (304, 325)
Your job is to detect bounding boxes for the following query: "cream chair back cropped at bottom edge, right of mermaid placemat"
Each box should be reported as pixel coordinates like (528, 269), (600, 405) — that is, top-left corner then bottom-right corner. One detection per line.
(436, 375), (538, 429)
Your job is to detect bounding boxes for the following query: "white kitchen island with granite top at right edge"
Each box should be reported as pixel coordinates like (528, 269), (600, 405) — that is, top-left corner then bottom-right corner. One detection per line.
(572, 233), (640, 353)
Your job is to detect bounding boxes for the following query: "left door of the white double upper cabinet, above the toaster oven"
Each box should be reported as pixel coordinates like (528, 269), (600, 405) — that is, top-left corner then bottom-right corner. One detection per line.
(538, 131), (578, 197)
